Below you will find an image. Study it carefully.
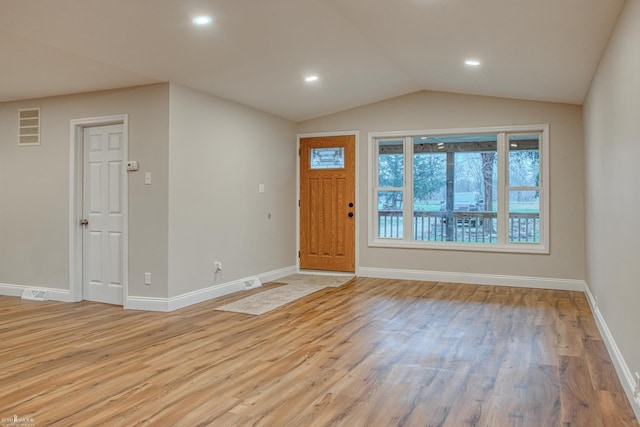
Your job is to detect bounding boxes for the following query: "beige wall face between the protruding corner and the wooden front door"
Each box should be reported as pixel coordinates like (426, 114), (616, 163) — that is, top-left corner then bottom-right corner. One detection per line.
(169, 83), (296, 297)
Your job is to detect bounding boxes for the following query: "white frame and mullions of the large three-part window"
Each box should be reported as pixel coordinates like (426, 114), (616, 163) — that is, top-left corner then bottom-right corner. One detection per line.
(368, 124), (549, 254)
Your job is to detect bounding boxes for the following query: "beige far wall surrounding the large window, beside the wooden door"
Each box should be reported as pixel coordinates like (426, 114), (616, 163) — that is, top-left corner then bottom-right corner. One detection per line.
(298, 92), (585, 280)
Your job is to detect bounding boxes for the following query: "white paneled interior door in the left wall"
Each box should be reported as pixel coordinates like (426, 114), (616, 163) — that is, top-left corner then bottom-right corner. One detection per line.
(82, 124), (126, 305)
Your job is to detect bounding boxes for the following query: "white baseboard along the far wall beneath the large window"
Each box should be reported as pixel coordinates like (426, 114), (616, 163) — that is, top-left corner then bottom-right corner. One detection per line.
(357, 267), (586, 292)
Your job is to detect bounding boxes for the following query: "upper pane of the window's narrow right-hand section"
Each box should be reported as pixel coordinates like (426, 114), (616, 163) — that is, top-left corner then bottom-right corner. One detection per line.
(509, 135), (540, 187)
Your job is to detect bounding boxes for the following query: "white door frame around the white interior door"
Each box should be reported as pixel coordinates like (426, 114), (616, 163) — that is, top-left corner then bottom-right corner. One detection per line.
(69, 114), (129, 308)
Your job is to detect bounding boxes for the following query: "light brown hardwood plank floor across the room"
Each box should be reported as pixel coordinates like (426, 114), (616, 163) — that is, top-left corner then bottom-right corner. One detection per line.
(0, 278), (639, 427)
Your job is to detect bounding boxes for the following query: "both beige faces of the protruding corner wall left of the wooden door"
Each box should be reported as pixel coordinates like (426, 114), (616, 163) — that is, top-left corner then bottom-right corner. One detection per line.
(0, 83), (297, 304)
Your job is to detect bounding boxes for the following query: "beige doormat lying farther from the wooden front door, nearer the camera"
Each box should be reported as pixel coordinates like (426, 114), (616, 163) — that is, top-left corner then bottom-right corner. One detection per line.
(216, 283), (326, 316)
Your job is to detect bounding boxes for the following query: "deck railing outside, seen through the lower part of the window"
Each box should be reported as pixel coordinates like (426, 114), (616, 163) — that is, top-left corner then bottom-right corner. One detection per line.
(378, 210), (540, 243)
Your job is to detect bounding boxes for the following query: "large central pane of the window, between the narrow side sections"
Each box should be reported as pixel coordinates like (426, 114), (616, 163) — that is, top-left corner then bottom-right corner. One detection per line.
(413, 134), (498, 243)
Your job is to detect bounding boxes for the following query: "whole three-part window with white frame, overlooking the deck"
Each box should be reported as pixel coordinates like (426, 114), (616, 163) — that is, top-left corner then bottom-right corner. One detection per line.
(369, 125), (549, 253)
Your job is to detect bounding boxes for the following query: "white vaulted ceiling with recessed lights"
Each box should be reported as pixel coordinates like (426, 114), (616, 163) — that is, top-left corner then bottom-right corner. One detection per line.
(0, 0), (624, 121)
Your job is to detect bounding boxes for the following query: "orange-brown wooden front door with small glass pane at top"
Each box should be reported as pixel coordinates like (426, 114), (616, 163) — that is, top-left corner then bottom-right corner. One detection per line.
(300, 135), (356, 272)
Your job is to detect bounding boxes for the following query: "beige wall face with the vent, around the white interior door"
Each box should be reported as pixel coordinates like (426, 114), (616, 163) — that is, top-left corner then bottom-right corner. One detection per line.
(0, 84), (169, 297)
